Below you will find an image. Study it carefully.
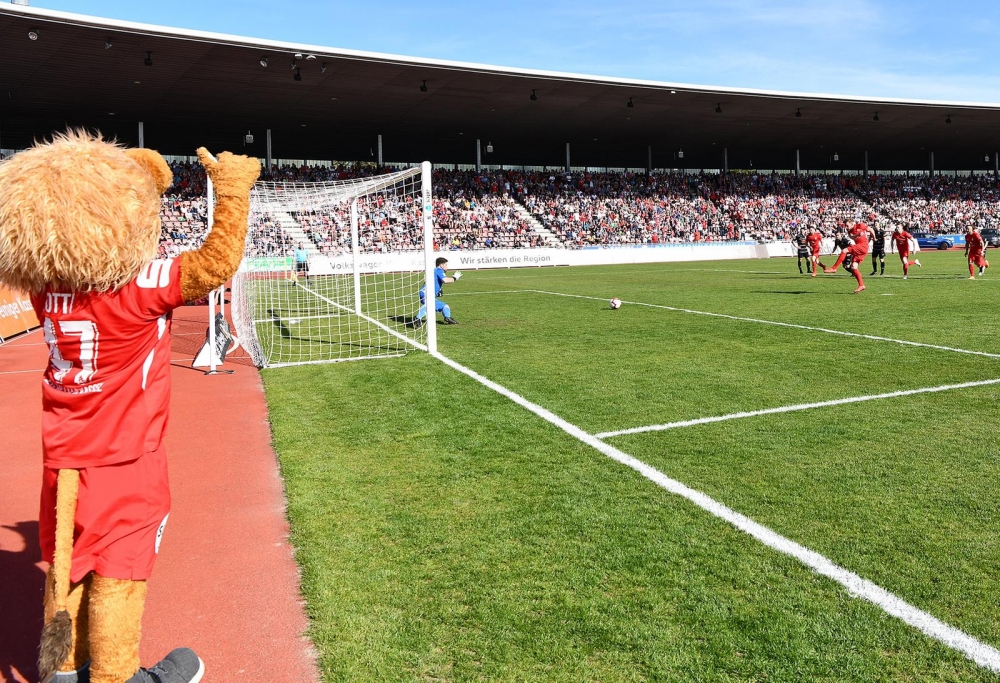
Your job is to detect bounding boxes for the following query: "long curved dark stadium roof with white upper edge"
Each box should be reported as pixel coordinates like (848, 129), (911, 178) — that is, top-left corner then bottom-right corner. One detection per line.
(0, 4), (1000, 170)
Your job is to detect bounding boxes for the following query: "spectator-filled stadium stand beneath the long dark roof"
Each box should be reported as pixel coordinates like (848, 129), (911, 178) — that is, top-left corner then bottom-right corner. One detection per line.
(146, 163), (1000, 256)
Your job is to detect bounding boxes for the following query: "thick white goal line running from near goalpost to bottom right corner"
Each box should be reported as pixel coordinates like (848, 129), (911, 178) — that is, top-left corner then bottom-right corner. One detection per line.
(431, 352), (1000, 673)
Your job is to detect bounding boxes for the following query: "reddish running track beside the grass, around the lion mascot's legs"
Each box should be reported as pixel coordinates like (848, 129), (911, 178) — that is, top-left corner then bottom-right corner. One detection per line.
(0, 307), (319, 683)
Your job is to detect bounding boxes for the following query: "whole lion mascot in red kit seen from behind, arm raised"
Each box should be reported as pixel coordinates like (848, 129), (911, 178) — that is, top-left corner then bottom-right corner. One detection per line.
(0, 132), (260, 683)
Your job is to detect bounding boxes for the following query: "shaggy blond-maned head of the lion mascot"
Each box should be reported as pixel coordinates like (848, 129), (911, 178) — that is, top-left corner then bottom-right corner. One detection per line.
(0, 131), (173, 293)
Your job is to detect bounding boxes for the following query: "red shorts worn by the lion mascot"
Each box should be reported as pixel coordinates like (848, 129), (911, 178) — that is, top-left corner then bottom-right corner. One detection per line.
(39, 446), (170, 582)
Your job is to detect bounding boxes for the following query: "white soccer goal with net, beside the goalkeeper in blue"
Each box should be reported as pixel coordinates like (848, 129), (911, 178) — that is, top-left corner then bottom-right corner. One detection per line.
(232, 162), (436, 368)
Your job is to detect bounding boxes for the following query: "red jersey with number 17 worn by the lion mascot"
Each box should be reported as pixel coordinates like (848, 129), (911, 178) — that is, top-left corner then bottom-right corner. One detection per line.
(31, 259), (184, 469)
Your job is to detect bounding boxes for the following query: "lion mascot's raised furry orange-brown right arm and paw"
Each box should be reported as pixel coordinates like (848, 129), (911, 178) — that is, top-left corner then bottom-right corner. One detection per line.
(180, 147), (260, 301)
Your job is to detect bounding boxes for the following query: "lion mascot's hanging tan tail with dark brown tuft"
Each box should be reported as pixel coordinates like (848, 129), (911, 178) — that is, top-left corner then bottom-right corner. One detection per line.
(38, 470), (80, 683)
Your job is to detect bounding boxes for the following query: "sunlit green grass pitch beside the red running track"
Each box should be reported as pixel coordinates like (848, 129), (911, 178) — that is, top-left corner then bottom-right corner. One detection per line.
(264, 252), (1000, 681)
